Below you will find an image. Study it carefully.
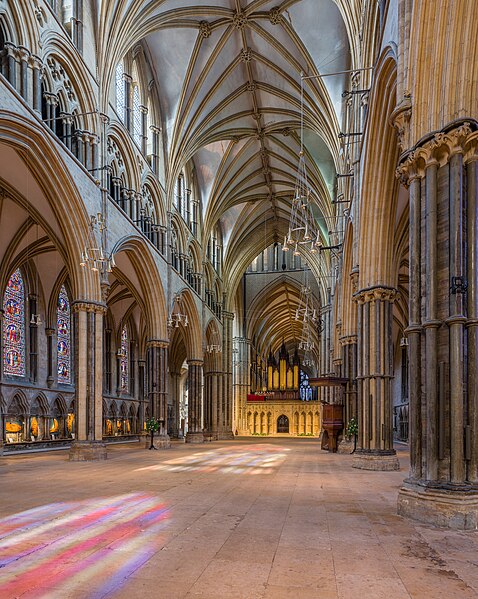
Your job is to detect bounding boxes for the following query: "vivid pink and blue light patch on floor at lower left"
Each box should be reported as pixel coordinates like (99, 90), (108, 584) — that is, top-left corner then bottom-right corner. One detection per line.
(0, 493), (168, 599)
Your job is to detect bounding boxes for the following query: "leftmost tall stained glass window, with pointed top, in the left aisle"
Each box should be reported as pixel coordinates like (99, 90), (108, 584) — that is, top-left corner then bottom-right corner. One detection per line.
(3, 269), (25, 376)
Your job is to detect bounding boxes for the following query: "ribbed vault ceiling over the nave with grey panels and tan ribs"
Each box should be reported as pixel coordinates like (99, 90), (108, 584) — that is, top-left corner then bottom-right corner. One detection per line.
(104, 0), (357, 354)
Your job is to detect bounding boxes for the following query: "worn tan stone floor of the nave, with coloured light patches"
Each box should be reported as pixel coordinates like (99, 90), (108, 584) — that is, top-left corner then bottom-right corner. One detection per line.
(0, 438), (478, 599)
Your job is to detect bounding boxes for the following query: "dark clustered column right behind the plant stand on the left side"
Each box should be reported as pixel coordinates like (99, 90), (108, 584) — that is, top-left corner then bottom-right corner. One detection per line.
(146, 339), (170, 448)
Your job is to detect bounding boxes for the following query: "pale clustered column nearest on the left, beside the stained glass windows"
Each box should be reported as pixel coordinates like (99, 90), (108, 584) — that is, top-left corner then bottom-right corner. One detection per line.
(69, 301), (106, 461)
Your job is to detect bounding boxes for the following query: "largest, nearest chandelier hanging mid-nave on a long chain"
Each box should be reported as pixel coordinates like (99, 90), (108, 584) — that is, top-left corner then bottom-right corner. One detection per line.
(282, 73), (322, 256)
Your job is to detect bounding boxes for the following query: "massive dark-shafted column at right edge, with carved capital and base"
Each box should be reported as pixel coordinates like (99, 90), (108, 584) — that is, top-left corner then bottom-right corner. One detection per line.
(397, 122), (478, 530)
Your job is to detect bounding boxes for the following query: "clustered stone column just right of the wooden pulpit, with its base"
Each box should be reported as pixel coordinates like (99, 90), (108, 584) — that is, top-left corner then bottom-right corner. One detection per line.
(353, 286), (400, 470)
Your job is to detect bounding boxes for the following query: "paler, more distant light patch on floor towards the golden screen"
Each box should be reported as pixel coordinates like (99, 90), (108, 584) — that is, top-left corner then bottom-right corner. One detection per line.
(138, 444), (290, 475)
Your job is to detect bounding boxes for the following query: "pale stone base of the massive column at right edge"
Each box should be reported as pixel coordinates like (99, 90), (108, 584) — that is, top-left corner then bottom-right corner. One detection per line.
(397, 482), (478, 530)
